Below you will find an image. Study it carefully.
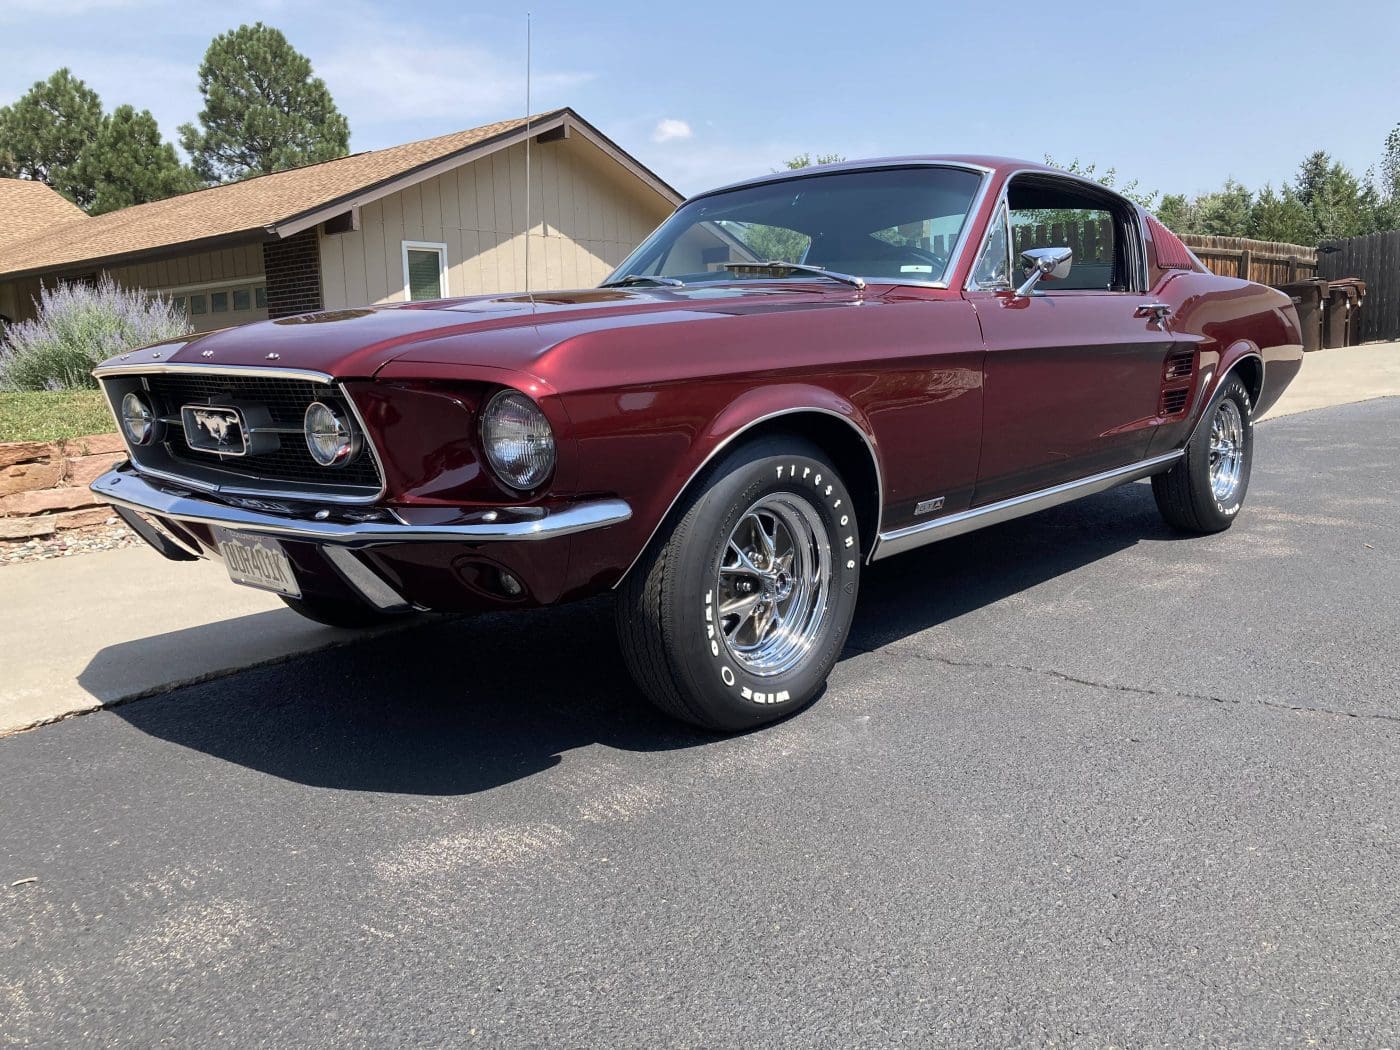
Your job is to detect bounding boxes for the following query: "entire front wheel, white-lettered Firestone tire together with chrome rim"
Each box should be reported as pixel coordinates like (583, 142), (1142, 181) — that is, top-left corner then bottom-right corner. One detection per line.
(616, 438), (861, 732)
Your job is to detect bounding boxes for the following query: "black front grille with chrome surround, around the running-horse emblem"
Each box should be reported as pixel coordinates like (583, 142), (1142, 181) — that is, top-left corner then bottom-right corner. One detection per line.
(94, 363), (385, 504)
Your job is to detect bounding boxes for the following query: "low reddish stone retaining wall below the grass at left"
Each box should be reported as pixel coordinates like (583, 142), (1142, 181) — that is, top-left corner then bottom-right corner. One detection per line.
(0, 434), (126, 540)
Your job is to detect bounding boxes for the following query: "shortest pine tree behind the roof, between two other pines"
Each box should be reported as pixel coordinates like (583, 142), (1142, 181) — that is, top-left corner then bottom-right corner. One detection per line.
(78, 105), (199, 216)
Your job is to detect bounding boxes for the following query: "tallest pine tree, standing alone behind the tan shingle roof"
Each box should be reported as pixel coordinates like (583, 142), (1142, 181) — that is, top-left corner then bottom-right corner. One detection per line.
(179, 22), (350, 182)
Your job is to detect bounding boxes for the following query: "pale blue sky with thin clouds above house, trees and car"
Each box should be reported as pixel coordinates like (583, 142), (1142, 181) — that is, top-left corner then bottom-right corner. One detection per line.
(0, 0), (1400, 201)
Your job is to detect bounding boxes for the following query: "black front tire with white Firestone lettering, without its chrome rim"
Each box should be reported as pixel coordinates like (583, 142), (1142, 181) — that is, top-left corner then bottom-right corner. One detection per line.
(666, 444), (861, 729)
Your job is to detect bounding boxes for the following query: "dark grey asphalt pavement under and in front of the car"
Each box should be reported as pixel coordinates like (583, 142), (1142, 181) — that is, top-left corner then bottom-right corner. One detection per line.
(0, 399), (1400, 1047)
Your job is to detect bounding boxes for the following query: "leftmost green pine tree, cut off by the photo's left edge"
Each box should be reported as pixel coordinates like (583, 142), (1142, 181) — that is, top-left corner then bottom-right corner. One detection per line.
(0, 69), (102, 207)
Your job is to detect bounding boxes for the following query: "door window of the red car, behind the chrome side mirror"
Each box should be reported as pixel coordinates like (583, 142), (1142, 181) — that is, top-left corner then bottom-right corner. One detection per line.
(1007, 179), (1133, 293)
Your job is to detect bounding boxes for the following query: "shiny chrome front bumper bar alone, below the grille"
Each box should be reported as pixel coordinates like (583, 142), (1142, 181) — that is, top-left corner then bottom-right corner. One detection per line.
(91, 463), (631, 547)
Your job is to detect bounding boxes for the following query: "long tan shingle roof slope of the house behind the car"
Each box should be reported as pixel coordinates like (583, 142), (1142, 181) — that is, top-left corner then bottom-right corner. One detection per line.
(0, 109), (593, 276)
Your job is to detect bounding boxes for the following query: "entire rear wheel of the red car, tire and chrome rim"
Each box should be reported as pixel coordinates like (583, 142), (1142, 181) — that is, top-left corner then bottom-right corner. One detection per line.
(1152, 375), (1254, 535)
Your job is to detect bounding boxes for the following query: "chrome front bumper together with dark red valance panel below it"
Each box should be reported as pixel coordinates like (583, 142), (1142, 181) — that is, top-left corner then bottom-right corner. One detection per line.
(91, 463), (631, 610)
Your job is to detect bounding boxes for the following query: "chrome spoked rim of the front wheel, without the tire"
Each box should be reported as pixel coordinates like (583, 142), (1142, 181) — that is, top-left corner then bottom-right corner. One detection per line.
(715, 493), (832, 678)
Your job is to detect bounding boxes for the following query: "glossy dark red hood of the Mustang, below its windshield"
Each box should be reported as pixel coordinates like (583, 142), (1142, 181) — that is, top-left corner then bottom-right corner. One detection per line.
(111, 288), (869, 379)
